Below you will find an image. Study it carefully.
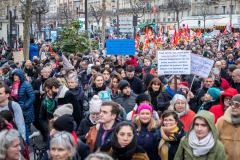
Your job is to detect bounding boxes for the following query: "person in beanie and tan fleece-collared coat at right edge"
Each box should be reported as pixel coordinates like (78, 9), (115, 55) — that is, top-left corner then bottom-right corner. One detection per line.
(216, 94), (240, 160)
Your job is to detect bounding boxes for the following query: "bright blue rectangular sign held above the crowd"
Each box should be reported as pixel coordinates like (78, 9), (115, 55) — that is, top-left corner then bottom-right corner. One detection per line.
(106, 39), (135, 55)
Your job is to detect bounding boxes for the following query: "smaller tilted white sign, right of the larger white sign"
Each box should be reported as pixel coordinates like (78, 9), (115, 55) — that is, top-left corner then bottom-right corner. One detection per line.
(191, 54), (214, 78)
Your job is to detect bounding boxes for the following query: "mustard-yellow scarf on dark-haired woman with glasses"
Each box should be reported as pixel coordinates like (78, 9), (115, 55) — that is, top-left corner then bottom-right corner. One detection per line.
(158, 124), (179, 160)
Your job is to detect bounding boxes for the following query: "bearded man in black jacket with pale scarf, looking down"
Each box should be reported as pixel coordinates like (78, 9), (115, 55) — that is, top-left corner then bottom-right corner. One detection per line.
(44, 78), (82, 126)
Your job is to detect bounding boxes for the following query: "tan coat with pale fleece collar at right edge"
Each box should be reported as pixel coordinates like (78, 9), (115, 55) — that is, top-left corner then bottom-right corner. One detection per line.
(216, 107), (240, 160)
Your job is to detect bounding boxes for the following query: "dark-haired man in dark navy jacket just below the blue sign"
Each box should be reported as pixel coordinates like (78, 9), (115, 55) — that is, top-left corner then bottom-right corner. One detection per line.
(124, 65), (143, 94)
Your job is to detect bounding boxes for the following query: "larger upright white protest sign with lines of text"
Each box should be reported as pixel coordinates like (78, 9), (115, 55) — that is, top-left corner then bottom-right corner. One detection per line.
(158, 50), (191, 75)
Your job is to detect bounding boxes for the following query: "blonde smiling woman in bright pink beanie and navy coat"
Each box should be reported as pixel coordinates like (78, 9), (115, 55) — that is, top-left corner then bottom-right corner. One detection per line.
(134, 103), (160, 160)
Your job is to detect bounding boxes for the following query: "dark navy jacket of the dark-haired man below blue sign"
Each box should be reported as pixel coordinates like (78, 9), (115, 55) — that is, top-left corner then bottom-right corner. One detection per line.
(123, 76), (143, 94)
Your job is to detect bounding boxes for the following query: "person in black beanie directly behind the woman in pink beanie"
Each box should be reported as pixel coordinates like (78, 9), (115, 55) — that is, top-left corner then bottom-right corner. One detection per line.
(126, 93), (159, 121)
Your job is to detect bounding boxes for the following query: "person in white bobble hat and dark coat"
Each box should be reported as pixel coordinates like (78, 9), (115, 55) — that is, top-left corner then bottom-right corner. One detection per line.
(77, 95), (102, 142)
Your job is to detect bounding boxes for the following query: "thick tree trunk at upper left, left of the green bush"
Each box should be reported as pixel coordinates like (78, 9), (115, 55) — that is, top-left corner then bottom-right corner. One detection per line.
(23, 0), (32, 60)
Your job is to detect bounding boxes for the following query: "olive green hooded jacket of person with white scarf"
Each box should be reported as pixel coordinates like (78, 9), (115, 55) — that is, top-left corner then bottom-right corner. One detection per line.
(174, 110), (226, 160)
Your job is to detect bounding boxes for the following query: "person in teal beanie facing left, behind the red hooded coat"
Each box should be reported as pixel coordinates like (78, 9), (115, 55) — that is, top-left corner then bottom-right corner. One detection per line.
(198, 87), (220, 111)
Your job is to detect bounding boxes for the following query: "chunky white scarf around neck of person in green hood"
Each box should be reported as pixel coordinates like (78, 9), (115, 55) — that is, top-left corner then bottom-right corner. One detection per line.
(188, 130), (215, 157)
